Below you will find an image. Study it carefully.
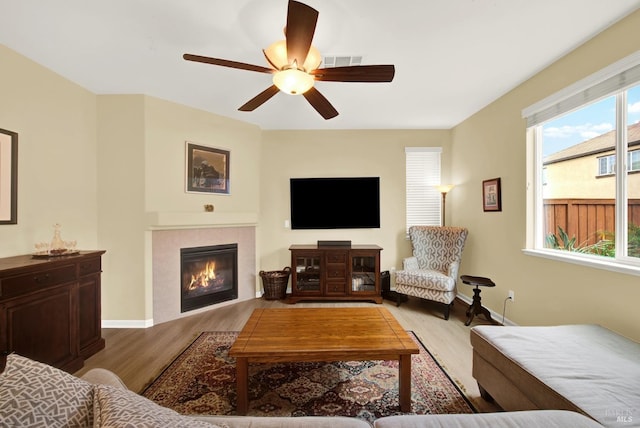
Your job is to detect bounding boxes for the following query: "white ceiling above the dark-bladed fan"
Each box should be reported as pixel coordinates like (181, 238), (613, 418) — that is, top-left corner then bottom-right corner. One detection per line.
(0, 0), (640, 129)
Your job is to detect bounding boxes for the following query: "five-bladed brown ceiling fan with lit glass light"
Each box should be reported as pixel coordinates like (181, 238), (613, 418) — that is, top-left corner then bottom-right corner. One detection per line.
(183, 0), (395, 119)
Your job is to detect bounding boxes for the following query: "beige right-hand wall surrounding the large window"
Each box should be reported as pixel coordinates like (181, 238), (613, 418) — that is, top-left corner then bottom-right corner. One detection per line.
(451, 12), (640, 340)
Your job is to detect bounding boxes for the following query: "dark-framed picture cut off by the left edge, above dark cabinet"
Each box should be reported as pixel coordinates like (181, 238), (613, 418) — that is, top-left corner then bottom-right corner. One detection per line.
(0, 129), (18, 224)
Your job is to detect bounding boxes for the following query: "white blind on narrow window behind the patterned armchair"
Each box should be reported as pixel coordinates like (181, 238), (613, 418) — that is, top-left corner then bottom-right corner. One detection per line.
(405, 147), (442, 230)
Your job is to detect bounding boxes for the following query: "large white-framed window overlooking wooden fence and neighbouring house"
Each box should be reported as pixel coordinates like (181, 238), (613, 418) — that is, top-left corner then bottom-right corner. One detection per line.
(523, 53), (640, 270)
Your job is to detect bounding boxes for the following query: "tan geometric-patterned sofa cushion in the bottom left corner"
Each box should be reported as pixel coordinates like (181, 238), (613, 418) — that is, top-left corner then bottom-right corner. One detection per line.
(0, 354), (93, 428)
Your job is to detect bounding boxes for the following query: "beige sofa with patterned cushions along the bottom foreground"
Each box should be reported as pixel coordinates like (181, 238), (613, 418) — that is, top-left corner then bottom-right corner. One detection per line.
(0, 354), (600, 428)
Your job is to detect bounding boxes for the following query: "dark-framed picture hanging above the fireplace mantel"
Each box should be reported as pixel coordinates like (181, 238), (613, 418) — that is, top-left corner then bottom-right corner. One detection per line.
(186, 141), (230, 194)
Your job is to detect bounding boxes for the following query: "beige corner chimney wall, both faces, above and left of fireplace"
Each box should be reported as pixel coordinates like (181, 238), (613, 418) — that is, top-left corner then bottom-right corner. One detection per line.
(98, 95), (261, 323)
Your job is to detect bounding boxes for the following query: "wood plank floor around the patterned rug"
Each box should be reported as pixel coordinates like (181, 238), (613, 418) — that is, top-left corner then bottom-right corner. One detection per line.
(76, 299), (498, 412)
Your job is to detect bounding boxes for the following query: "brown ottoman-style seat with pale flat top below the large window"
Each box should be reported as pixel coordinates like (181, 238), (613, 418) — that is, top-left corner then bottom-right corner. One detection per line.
(471, 325), (640, 427)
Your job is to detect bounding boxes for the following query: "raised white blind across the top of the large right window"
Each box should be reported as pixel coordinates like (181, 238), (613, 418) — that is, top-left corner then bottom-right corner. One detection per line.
(522, 51), (640, 127)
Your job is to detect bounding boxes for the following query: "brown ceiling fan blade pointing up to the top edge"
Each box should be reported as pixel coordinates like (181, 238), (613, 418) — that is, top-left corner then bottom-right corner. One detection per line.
(285, 0), (318, 67)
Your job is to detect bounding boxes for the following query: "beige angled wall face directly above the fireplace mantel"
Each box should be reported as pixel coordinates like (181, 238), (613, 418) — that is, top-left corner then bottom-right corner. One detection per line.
(145, 97), (262, 216)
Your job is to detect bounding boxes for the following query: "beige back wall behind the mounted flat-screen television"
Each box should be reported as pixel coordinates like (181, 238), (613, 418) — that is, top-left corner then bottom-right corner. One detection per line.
(259, 130), (451, 276)
